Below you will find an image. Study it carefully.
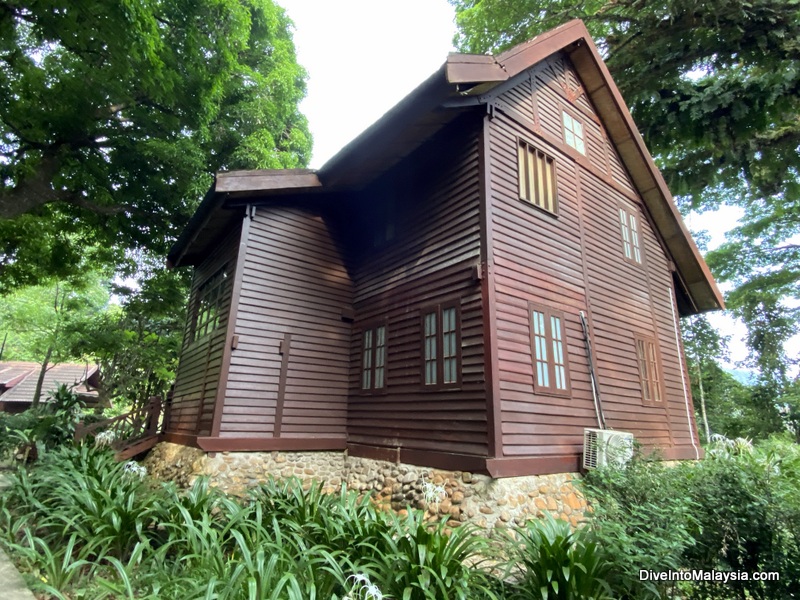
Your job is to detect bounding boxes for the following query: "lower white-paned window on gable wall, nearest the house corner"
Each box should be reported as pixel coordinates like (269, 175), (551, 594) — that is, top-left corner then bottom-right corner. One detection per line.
(530, 304), (569, 394)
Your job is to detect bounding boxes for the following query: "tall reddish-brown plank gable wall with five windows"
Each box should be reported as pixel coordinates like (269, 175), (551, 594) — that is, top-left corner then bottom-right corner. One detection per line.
(490, 56), (692, 468)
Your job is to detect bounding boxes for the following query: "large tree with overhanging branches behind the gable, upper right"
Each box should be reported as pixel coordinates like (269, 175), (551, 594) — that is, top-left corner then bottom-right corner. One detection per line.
(450, 0), (800, 406)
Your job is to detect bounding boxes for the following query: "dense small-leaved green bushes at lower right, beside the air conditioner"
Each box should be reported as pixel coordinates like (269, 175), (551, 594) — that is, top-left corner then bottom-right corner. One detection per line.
(585, 438), (800, 600)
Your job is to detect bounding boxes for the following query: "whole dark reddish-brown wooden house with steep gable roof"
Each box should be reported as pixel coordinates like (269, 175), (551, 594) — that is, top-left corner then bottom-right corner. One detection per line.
(165, 21), (723, 477)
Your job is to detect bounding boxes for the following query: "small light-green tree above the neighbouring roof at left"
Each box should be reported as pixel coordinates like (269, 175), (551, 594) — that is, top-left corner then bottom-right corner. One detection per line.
(0, 274), (109, 407)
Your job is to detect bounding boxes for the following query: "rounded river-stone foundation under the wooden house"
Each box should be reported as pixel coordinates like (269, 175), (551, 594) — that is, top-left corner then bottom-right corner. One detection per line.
(145, 442), (587, 530)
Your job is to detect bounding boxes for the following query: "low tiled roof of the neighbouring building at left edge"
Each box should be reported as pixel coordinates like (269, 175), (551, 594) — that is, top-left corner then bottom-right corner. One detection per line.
(0, 362), (99, 402)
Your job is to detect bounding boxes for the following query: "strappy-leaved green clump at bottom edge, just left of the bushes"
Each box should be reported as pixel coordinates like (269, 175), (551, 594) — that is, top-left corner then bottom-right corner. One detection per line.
(509, 513), (613, 600)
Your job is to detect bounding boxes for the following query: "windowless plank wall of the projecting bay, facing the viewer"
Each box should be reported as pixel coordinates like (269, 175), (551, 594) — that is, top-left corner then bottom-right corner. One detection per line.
(219, 206), (352, 440)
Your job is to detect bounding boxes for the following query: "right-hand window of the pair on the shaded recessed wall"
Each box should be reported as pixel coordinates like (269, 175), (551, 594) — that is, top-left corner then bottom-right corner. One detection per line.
(422, 305), (461, 387)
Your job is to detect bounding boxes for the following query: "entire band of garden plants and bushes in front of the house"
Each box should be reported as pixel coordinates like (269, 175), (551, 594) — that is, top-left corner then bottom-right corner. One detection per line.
(0, 426), (800, 600)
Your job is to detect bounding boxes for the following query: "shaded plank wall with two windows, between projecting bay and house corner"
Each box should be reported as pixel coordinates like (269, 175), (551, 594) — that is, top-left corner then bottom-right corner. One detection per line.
(348, 118), (488, 462)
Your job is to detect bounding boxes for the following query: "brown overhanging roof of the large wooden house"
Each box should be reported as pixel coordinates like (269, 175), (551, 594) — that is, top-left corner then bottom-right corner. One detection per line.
(169, 20), (724, 312)
